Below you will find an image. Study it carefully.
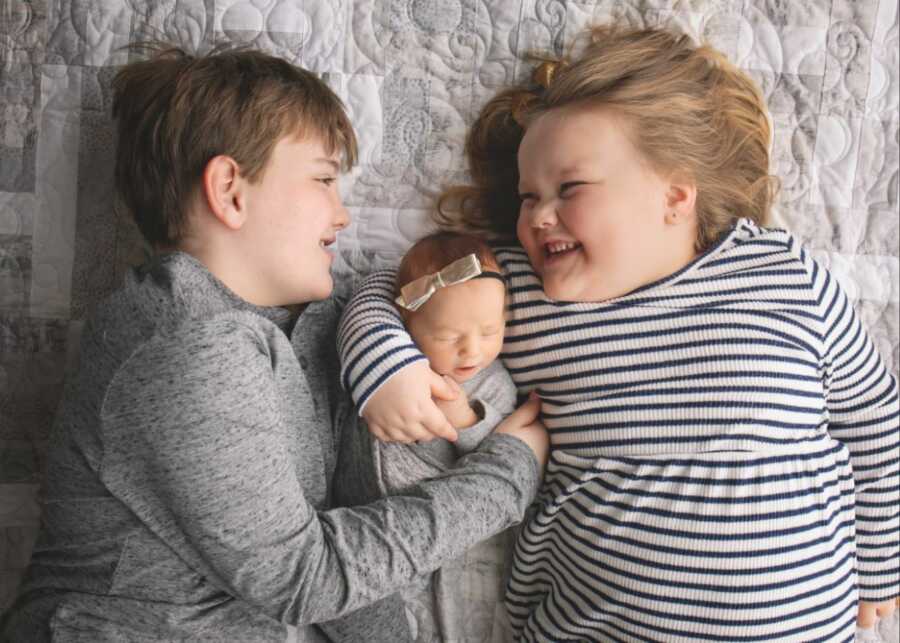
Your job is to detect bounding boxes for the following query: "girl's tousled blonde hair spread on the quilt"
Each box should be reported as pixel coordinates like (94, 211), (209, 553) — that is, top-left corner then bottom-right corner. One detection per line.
(436, 25), (778, 251)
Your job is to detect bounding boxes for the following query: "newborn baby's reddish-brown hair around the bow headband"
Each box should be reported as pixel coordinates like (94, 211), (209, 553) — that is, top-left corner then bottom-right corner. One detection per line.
(394, 232), (500, 296)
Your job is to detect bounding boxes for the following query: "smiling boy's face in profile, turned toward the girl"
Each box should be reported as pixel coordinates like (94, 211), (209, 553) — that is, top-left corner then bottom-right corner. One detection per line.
(241, 136), (350, 306)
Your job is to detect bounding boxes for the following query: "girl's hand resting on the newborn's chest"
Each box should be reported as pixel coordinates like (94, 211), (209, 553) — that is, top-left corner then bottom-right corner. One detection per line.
(362, 360), (457, 443)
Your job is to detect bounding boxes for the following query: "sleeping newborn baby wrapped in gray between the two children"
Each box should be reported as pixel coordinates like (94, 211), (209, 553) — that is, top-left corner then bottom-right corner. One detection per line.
(329, 234), (516, 641)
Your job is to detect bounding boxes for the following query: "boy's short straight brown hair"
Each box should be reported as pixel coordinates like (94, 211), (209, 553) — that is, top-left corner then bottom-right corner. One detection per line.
(113, 43), (356, 247)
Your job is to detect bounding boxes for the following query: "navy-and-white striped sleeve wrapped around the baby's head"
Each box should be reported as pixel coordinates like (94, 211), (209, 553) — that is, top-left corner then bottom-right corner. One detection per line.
(337, 270), (425, 414)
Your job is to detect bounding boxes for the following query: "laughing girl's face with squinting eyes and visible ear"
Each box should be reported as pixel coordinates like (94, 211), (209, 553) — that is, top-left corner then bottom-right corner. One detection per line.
(517, 107), (696, 301)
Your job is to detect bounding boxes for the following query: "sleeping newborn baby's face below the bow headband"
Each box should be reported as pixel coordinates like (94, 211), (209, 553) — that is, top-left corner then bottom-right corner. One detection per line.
(406, 278), (506, 383)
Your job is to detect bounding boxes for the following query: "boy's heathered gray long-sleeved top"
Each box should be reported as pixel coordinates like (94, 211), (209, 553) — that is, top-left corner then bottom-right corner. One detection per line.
(4, 253), (538, 642)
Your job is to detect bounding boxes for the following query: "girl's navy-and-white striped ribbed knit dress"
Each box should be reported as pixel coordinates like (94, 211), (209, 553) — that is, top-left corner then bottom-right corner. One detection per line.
(342, 220), (900, 642)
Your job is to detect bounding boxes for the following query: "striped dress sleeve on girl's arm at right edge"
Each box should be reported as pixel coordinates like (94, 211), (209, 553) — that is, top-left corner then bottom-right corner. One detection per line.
(817, 267), (900, 603)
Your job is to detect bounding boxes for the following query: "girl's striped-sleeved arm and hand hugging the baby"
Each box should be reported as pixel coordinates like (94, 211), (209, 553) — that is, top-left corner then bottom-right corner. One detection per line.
(338, 270), (456, 442)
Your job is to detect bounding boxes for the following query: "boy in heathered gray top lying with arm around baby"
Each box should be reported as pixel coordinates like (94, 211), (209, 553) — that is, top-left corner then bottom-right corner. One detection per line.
(0, 42), (546, 641)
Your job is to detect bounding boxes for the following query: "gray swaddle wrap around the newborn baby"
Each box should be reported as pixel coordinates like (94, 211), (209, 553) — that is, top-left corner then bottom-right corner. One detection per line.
(327, 360), (516, 643)
